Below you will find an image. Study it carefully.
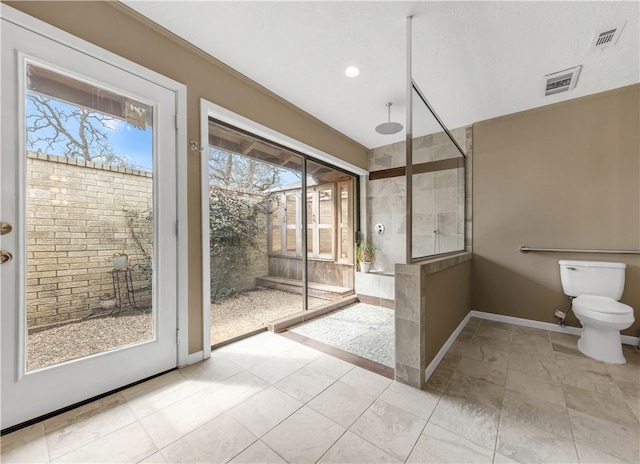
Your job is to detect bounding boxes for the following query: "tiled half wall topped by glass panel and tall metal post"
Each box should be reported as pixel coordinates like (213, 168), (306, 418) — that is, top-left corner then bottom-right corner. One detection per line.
(394, 17), (471, 389)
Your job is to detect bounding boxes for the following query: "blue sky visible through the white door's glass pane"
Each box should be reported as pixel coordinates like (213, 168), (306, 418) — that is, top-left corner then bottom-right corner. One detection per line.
(26, 98), (153, 171)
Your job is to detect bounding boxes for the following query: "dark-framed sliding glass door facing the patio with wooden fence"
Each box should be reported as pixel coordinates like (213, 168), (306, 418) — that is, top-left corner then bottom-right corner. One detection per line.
(207, 119), (355, 345)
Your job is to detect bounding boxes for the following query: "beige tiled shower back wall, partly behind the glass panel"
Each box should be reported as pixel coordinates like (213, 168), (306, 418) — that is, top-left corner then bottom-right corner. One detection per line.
(367, 126), (473, 274)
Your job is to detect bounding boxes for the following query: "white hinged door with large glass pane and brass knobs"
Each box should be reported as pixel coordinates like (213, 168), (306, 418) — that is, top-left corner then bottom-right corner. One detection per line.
(0, 18), (177, 429)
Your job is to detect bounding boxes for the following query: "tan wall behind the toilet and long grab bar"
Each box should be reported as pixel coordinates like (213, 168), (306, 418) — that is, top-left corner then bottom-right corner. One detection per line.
(472, 85), (640, 336)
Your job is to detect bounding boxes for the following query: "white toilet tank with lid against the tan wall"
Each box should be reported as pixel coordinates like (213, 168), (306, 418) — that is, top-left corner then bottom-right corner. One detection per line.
(559, 260), (627, 301)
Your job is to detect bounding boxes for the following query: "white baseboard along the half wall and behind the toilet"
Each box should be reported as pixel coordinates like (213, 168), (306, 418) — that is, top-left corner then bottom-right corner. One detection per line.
(425, 310), (640, 382)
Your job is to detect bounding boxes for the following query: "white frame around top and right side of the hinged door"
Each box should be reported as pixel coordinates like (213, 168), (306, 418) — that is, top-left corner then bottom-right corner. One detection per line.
(0, 4), (189, 374)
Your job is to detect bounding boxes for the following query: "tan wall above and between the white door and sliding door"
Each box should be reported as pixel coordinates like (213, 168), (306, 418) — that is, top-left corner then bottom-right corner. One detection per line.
(4, 1), (367, 353)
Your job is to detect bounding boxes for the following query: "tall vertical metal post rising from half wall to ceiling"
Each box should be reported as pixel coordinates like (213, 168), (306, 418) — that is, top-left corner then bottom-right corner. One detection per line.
(405, 16), (413, 264)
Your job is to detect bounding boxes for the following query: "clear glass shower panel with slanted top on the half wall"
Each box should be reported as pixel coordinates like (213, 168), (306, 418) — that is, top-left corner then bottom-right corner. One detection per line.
(411, 89), (465, 259)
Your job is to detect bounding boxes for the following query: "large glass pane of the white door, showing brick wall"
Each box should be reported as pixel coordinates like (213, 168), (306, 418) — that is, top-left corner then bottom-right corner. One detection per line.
(25, 63), (154, 371)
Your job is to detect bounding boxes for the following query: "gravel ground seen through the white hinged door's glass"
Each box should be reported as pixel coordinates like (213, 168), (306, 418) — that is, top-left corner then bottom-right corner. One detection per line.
(27, 313), (152, 370)
